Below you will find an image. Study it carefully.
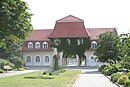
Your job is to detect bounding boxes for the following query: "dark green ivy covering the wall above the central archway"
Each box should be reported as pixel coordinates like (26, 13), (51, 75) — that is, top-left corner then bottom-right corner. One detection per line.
(51, 37), (90, 65)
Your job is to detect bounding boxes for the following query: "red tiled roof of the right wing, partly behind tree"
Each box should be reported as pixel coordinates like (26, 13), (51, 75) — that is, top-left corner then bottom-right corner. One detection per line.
(86, 28), (117, 39)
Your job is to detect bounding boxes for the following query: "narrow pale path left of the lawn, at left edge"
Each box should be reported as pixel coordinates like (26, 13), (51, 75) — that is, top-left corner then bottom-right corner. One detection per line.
(0, 70), (37, 78)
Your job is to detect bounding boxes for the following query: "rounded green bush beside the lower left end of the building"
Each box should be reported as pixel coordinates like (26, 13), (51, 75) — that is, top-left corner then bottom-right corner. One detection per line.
(10, 56), (24, 69)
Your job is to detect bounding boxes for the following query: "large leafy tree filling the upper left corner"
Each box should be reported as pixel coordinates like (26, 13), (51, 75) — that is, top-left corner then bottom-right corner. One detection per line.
(0, 0), (32, 58)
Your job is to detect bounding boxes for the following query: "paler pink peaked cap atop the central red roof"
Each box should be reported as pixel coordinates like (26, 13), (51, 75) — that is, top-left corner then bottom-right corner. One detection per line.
(56, 15), (83, 22)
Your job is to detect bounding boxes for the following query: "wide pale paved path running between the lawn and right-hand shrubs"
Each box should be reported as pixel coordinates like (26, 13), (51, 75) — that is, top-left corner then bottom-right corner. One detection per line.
(73, 69), (118, 87)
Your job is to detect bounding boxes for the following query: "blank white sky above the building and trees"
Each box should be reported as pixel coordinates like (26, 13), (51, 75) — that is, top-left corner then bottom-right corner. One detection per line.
(23, 0), (130, 34)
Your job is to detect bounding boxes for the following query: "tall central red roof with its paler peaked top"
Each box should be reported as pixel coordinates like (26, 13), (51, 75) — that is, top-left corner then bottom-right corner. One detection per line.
(50, 15), (89, 38)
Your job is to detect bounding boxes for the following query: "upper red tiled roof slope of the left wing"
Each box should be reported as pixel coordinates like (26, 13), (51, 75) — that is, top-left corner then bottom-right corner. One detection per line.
(25, 29), (53, 41)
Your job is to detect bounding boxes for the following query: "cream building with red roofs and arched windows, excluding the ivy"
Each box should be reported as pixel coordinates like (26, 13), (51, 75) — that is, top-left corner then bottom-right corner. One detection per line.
(23, 15), (117, 66)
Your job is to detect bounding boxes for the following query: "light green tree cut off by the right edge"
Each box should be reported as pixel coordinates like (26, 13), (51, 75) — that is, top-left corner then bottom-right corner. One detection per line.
(117, 33), (130, 70)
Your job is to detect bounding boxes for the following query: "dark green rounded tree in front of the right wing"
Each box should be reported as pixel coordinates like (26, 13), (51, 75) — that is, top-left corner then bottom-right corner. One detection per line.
(95, 32), (120, 63)
